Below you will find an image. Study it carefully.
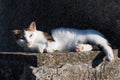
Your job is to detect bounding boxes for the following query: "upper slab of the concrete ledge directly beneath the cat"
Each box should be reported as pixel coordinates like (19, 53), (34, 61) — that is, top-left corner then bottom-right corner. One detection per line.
(0, 49), (120, 67)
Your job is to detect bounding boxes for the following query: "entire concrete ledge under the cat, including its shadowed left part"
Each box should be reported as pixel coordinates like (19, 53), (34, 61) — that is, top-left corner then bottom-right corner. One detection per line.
(0, 49), (120, 80)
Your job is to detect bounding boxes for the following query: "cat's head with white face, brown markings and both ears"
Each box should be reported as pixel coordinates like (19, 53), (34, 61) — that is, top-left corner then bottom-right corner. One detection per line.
(12, 21), (37, 47)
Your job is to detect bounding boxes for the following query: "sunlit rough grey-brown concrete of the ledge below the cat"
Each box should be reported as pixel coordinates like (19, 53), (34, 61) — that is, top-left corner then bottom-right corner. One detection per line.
(13, 50), (120, 80)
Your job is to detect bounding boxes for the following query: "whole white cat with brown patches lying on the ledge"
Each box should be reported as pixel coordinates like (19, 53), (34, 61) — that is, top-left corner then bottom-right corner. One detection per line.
(13, 21), (114, 61)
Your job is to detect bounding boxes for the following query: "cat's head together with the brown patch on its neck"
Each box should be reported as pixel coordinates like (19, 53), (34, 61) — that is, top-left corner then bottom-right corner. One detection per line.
(12, 21), (54, 47)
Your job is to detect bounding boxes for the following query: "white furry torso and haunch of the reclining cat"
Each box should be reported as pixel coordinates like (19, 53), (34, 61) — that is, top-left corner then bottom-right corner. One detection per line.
(52, 28), (104, 51)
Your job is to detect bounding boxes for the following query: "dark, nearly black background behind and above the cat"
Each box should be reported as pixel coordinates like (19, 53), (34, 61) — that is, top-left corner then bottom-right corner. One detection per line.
(0, 0), (120, 51)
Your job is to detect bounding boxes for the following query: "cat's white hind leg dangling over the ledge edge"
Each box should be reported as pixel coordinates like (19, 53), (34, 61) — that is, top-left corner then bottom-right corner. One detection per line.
(87, 35), (114, 61)
